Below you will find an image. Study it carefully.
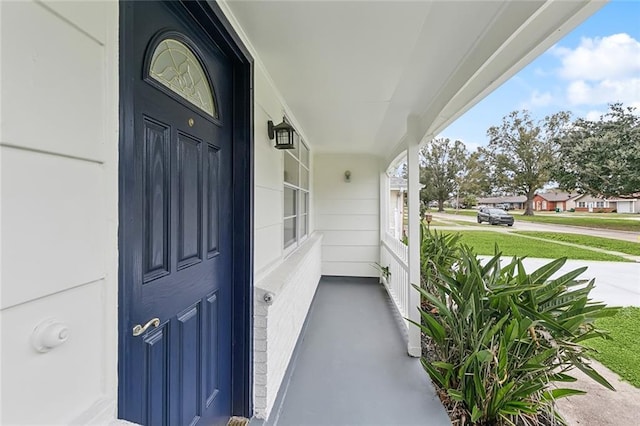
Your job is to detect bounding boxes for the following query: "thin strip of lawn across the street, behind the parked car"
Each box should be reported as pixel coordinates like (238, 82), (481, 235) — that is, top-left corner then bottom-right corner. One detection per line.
(446, 209), (640, 232)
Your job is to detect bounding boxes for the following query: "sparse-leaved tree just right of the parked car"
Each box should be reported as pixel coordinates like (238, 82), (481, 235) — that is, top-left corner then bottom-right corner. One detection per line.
(487, 111), (570, 216)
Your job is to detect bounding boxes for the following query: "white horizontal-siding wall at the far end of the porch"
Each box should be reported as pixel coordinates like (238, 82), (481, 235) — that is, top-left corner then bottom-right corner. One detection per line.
(314, 154), (380, 277)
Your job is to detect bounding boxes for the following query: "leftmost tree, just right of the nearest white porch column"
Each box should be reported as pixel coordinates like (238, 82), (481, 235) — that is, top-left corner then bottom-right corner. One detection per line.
(420, 139), (467, 211)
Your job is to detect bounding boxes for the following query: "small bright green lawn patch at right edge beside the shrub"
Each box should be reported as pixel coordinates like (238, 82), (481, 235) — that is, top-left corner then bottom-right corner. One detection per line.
(585, 307), (640, 388)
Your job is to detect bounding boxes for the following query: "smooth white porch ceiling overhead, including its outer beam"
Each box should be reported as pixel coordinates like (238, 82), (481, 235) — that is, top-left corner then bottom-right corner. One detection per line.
(228, 0), (605, 157)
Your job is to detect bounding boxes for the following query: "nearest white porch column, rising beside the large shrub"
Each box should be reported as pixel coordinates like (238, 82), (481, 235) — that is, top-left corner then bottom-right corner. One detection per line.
(407, 116), (422, 357)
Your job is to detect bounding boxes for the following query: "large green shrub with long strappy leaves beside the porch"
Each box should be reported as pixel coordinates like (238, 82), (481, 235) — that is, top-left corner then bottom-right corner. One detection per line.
(414, 245), (616, 425)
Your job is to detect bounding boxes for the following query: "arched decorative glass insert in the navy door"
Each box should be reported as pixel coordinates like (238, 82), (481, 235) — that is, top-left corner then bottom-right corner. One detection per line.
(149, 38), (218, 118)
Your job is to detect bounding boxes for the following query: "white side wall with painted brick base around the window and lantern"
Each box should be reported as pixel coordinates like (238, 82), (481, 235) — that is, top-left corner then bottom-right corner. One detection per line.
(219, 2), (324, 418)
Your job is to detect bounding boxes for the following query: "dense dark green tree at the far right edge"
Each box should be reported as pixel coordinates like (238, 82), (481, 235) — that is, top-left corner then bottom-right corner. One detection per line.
(553, 103), (640, 197)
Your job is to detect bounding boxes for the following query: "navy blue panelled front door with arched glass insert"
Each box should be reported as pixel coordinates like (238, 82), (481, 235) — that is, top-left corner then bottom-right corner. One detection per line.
(119, 1), (233, 426)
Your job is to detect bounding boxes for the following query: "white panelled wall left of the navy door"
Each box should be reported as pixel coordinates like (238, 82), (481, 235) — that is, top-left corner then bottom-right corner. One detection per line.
(0, 2), (118, 424)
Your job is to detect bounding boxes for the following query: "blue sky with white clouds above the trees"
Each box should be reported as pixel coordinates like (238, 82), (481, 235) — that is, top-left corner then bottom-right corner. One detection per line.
(439, 0), (640, 151)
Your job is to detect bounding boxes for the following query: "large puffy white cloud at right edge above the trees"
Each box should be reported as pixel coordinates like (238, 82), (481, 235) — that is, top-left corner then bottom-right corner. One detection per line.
(552, 33), (640, 106)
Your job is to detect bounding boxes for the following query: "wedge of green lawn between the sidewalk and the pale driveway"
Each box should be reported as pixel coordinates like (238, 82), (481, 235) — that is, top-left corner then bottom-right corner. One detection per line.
(445, 231), (627, 262)
